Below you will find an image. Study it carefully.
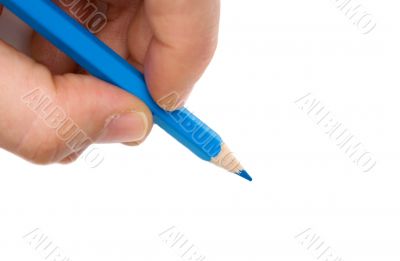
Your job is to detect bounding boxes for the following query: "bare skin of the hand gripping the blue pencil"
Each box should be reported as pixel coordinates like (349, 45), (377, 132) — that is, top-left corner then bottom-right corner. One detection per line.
(0, 0), (220, 164)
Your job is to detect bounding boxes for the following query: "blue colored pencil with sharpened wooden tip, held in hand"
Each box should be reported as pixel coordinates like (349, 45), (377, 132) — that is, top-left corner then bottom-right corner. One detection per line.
(0, 0), (252, 181)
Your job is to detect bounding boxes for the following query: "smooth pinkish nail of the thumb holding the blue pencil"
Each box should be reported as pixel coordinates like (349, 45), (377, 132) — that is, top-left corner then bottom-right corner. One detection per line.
(98, 111), (148, 143)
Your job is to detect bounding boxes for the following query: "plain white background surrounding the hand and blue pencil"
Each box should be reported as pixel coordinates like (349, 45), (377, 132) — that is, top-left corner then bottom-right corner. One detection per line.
(0, 0), (400, 261)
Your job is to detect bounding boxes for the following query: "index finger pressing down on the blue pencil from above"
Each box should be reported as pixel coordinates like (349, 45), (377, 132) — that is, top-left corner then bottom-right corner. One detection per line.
(137, 0), (220, 109)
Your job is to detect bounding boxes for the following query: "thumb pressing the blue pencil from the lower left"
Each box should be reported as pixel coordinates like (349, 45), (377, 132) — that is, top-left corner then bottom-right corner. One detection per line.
(0, 41), (152, 164)
